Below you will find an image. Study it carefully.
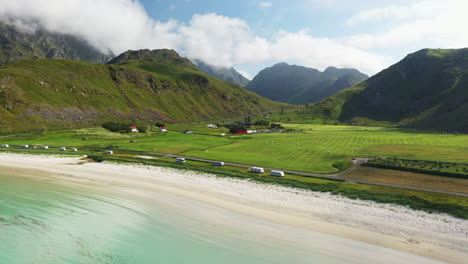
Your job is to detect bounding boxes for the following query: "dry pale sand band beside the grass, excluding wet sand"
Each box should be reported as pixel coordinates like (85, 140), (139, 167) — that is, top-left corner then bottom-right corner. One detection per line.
(0, 154), (468, 263)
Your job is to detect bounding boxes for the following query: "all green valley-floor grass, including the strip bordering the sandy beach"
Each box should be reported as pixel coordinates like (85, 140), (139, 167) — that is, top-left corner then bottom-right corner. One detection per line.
(0, 124), (468, 219)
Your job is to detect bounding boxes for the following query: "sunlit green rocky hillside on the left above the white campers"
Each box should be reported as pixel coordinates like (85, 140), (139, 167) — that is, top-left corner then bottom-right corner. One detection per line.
(0, 50), (286, 133)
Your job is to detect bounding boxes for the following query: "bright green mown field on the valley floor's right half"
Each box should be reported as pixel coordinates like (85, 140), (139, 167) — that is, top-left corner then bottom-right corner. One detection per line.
(184, 124), (468, 173)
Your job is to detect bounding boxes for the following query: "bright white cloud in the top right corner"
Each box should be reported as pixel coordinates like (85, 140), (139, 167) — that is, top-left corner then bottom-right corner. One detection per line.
(347, 0), (468, 52)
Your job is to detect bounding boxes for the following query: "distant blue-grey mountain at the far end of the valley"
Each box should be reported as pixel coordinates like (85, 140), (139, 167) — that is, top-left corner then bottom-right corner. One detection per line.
(246, 62), (368, 104)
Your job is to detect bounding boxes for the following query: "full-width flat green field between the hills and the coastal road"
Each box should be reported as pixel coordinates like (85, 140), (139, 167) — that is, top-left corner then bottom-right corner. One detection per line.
(0, 124), (468, 173)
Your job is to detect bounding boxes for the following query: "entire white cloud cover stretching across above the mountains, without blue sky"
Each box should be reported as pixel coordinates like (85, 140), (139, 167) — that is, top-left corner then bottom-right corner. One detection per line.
(0, 0), (468, 74)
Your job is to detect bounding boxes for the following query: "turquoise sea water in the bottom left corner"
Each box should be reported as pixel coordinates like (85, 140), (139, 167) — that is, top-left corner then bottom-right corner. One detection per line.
(0, 175), (341, 264)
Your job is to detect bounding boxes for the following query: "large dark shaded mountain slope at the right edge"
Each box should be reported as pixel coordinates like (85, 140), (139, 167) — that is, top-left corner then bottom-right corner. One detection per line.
(306, 49), (468, 132)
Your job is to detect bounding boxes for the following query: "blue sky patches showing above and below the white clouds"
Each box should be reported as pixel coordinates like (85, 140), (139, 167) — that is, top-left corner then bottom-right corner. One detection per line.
(137, 0), (468, 77)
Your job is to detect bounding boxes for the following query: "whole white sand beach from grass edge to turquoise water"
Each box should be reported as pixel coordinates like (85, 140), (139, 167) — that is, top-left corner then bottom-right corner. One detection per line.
(0, 153), (468, 263)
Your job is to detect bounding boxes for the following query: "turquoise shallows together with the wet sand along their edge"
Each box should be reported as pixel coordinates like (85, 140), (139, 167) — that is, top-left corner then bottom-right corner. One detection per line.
(0, 171), (446, 264)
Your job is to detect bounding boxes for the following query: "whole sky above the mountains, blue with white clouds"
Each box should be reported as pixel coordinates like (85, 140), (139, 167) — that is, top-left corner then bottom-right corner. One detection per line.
(0, 0), (468, 78)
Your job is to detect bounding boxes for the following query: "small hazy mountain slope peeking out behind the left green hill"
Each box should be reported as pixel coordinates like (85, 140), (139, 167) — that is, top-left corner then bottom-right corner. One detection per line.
(193, 60), (249, 87)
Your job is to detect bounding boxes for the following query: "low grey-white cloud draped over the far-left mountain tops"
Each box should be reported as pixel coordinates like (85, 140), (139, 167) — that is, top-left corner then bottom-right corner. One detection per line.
(0, 0), (179, 53)
